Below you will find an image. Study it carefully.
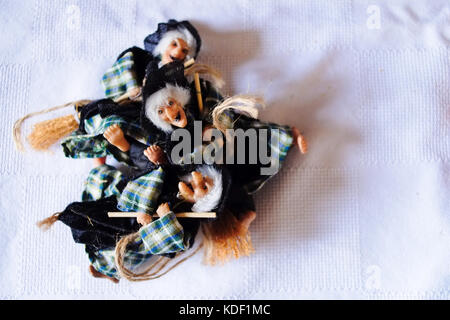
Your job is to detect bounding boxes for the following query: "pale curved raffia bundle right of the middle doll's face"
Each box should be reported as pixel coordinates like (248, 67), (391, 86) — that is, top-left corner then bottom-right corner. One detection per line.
(212, 94), (265, 133)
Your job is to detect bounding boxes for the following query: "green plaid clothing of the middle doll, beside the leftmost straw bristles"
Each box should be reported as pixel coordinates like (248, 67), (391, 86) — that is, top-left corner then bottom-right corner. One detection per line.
(61, 114), (151, 164)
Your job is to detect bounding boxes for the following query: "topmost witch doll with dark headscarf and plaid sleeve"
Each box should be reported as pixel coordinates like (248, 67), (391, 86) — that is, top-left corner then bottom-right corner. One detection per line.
(102, 19), (201, 99)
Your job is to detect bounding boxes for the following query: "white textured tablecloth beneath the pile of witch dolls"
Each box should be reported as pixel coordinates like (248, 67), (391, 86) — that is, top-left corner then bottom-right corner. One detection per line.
(0, 0), (450, 299)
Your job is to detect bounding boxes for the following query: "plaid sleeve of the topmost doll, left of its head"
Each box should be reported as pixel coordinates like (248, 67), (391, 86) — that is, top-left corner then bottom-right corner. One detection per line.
(102, 52), (139, 99)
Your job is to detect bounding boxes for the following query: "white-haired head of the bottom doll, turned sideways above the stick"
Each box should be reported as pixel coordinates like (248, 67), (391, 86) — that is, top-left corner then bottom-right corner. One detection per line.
(178, 165), (223, 212)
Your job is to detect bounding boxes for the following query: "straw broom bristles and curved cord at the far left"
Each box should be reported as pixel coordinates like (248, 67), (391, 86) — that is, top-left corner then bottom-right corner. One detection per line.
(13, 100), (91, 152)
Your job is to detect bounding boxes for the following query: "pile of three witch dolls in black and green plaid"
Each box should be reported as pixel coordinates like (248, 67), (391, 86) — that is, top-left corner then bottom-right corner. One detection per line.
(22, 20), (307, 282)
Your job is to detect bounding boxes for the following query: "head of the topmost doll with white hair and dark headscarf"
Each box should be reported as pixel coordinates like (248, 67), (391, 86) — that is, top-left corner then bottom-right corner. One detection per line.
(144, 19), (201, 65)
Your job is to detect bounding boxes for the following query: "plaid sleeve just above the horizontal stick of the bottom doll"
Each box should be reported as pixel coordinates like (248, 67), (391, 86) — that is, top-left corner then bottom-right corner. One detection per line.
(117, 168), (164, 214)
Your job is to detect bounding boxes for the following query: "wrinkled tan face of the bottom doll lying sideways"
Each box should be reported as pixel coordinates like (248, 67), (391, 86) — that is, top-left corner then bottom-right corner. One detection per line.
(178, 171), (214, 203)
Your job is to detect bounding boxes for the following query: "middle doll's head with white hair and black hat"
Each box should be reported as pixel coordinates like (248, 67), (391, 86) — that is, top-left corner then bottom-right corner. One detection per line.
(142, 62), (191, 133)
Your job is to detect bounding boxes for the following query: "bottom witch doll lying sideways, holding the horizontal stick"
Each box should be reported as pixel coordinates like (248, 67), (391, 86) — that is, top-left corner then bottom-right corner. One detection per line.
(41, 165), (254, 282)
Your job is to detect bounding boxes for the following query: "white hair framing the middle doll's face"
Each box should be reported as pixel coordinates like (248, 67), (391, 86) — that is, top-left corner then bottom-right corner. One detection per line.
(145, 84), (191, 133)
